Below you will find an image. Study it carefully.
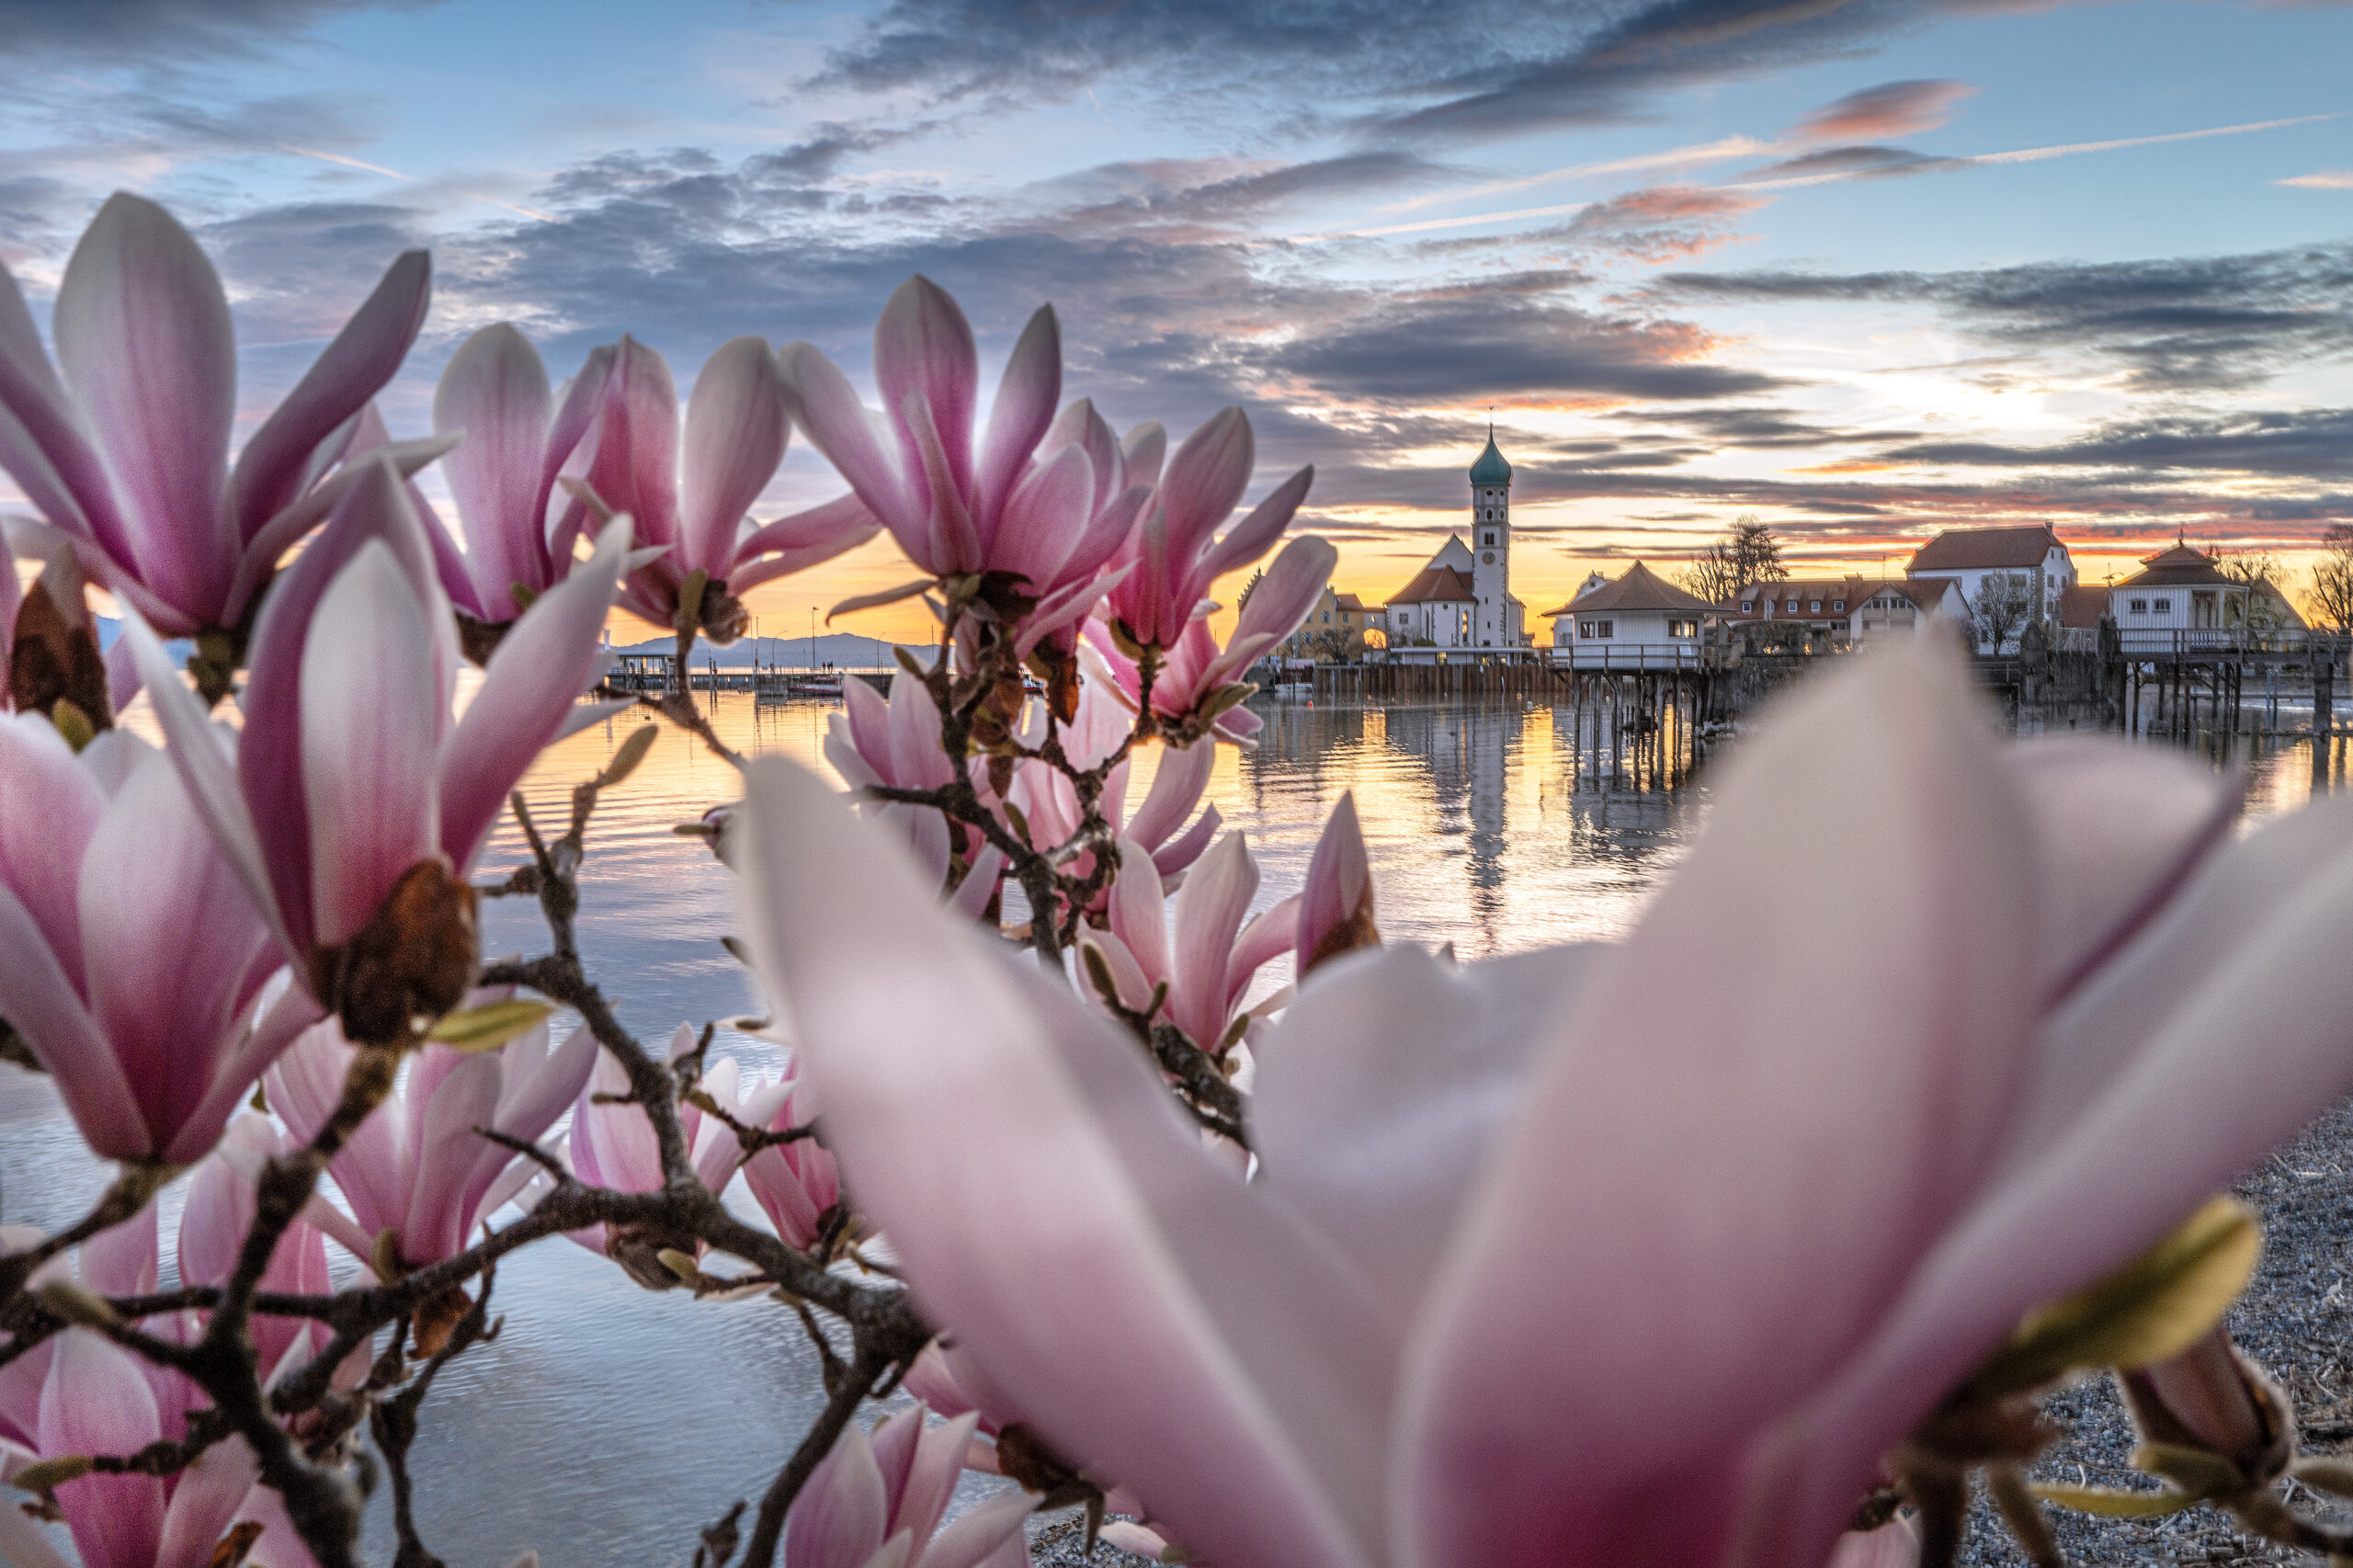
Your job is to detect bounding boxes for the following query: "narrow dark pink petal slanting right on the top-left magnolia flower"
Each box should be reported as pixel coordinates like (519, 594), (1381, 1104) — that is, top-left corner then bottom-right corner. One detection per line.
(223, 250), (433, 537)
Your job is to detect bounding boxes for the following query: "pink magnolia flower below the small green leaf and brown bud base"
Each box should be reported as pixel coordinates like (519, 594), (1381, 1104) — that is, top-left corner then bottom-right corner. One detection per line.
(261, 991), (597, 1269)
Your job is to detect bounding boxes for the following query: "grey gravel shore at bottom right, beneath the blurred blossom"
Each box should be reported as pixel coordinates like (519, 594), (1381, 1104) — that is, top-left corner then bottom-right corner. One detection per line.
(1030, 1102), (2353, 1568)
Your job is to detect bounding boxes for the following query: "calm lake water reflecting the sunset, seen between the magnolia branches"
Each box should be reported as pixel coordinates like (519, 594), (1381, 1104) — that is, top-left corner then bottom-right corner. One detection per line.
(0, 695), (2346, 1568)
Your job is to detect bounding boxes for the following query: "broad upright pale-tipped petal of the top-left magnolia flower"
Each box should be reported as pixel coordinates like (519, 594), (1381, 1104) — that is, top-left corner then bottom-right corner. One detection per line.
(51, 190), (238, 617)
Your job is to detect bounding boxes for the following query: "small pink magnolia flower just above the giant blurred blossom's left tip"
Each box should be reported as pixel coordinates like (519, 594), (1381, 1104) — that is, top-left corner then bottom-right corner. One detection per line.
(826, 676), (1005, 918)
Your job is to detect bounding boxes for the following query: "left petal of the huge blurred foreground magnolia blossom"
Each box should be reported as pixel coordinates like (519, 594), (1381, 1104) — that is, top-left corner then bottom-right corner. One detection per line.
(741, 758), (1395, 1568)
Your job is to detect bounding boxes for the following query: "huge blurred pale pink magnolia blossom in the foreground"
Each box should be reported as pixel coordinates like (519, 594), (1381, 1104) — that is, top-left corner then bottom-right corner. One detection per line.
(741, 642), (2353, 1568)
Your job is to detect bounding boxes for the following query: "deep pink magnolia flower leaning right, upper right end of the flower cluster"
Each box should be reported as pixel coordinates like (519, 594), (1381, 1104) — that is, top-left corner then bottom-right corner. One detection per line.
(1106, 407), (1320, 650)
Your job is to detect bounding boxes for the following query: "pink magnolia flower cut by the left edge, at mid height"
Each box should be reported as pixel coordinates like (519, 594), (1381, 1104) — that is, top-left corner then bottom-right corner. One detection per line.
(0, 715), (318, 1165)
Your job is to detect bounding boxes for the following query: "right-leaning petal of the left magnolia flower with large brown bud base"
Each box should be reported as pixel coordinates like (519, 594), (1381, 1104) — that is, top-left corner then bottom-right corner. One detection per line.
(440, 520), (629, 873)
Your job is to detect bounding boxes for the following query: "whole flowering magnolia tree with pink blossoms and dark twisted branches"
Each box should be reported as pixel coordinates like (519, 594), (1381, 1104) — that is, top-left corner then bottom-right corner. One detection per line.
(0, 198), (2353, 1568)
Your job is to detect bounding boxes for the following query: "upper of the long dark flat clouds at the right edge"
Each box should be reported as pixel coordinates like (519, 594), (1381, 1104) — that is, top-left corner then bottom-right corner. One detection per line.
(1656, 243), (2353, 391)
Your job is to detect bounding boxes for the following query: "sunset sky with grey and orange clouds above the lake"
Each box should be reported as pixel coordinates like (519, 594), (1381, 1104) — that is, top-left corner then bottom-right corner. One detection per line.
(0, 0), (2353, 641)
